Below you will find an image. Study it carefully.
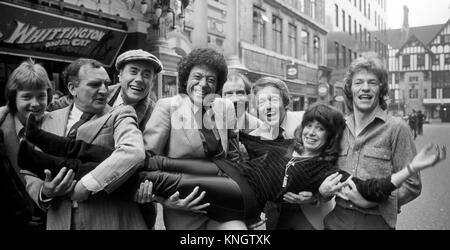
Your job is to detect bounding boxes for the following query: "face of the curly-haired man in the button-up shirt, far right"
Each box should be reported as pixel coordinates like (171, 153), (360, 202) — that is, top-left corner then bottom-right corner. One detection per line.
(352, 70), (380, 113)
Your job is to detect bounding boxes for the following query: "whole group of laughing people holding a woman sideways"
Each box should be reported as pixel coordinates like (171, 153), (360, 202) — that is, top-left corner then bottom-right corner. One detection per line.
(0, 49), (446, 230)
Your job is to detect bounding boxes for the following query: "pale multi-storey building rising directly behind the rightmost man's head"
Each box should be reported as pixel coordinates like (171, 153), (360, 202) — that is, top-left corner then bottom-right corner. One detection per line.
(325, 0), (388, 109)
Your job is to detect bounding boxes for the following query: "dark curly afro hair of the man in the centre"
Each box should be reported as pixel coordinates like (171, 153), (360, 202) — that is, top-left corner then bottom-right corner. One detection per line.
(178, 48), (228, 94)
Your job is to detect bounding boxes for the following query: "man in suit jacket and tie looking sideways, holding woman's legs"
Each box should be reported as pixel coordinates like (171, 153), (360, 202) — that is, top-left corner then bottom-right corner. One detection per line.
(25, 59), (147, 230)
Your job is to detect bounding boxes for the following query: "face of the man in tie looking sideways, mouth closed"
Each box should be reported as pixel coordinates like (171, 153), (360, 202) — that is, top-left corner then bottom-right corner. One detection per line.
(68, 64), (111, 114)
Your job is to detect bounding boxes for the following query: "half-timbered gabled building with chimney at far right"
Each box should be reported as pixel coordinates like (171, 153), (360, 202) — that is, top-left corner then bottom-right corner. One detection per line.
(388, 6), (450, 122)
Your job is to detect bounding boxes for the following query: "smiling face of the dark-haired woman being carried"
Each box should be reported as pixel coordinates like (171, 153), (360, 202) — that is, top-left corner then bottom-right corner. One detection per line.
(302, 121), (327, 156)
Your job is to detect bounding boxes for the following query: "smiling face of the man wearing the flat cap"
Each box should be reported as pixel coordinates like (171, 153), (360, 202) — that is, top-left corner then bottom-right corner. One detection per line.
(119, 61), (155, 105)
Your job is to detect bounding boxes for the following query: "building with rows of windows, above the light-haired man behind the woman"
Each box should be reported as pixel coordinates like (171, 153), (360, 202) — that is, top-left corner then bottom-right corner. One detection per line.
(224, 0), (328, 111)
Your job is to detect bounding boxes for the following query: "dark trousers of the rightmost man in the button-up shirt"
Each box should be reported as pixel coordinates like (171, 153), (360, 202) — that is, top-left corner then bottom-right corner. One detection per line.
(324, 204), (395, 230)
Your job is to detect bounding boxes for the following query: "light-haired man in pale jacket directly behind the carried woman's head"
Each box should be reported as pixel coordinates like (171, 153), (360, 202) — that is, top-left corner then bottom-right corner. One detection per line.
(250, 77), (333, 230)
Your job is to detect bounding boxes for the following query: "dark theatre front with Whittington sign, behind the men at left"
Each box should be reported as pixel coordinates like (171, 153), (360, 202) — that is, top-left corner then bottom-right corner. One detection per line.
(0, 1), (127, 105)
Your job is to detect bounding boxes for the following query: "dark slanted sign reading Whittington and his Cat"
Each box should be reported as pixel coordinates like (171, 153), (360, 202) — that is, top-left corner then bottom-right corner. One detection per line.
(0, 3), (127, 66)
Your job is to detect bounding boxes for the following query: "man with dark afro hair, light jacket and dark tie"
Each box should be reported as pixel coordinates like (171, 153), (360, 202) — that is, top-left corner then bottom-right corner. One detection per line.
(144, 49), (245, 230)
